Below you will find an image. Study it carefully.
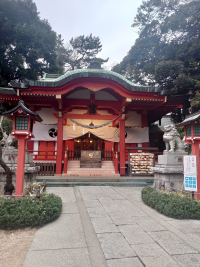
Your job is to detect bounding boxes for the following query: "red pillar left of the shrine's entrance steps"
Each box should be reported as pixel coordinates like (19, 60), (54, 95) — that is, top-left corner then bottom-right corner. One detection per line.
(56, 117), (63, 174)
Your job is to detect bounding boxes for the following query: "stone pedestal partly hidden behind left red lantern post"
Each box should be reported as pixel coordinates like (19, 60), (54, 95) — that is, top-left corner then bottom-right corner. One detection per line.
(0, 147), (40, 195)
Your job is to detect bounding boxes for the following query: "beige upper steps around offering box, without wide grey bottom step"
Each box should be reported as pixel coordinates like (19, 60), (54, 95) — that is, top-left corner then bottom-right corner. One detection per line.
(62, 160), (120, 177)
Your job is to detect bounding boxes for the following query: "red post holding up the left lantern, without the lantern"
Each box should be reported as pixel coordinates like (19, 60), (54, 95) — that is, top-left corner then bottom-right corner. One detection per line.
(15, 135), (27, 196)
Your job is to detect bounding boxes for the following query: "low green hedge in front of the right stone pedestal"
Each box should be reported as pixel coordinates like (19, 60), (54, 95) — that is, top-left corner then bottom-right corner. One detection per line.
(142, 187), (200, 220)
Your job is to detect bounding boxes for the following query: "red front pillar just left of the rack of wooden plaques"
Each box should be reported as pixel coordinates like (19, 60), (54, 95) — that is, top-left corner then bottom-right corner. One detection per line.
(119, 120), (126, 175)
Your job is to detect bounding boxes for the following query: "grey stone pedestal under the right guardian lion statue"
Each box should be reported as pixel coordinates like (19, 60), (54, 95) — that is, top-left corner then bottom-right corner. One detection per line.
(151, 152), (188, 191)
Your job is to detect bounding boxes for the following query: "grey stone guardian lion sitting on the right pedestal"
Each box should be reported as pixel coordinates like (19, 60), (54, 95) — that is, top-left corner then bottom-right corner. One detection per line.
(163, 124), (185, 152)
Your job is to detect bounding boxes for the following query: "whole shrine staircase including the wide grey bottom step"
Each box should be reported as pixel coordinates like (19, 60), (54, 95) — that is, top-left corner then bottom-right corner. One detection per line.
(36, 160), (154, 187)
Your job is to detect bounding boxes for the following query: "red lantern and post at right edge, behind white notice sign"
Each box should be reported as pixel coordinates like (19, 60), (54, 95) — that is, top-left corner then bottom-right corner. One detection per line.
(177, 111), (200, 199)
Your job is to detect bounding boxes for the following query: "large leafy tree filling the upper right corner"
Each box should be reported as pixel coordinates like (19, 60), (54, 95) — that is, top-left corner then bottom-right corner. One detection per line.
(113, 0), (200, 120)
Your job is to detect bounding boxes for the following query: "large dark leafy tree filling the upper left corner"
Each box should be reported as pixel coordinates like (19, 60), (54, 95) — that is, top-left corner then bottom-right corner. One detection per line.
(0, 0), (63, 86)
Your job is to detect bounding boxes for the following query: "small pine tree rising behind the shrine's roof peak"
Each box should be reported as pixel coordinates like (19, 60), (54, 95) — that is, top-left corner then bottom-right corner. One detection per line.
(61, 34), (108, 71)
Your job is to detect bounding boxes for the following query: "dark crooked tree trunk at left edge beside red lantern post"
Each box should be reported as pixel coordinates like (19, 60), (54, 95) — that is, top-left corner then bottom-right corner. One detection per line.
(0, 145), (14, 195)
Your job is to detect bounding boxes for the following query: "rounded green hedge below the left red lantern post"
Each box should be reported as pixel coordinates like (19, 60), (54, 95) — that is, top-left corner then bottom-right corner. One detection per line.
(0, 194), (62, 229)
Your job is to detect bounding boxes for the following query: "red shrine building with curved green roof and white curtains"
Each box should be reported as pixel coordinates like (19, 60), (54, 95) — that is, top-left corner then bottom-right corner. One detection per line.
(0, 64), (182, 175)
